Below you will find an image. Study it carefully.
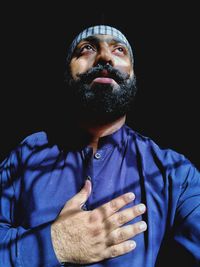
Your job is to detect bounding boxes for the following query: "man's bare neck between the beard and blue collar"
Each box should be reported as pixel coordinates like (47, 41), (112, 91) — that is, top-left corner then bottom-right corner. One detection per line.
(80, 116), (126, 153)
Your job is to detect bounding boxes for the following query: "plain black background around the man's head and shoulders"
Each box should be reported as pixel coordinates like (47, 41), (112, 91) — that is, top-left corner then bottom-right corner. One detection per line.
(0, 1), (200, 168)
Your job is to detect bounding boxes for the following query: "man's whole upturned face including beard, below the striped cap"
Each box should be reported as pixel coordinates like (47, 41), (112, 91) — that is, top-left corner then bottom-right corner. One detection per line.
(67, 35), (136, 123)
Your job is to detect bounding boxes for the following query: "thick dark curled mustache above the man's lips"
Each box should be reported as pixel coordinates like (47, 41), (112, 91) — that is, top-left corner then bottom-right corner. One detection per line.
(77, 64), (129, 83)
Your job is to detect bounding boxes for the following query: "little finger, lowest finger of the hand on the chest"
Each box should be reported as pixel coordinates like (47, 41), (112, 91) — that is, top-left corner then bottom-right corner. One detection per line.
(105, 240), (136, 259)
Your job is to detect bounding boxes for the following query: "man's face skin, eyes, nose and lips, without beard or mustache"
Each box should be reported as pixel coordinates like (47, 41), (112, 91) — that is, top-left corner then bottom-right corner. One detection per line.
(70, 35), (133, 82)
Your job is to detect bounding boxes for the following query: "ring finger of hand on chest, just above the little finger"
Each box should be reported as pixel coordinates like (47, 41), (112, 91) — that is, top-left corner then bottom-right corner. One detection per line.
(107, 221), (147, 246)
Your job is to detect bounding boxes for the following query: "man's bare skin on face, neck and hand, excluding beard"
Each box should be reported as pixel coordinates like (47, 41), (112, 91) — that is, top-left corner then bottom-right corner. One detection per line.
(51, 35), (147, 264)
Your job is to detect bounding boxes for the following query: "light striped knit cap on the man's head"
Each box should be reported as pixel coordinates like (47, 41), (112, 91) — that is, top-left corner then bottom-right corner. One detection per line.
(67, 25), (134, 63)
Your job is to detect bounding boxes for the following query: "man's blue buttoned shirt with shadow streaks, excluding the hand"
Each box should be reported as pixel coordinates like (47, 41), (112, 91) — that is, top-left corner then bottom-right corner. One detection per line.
(0, 125), (200, 267)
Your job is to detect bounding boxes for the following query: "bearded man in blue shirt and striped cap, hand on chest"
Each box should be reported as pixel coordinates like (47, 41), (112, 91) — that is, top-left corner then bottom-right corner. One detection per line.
(0, 25), (200, 267)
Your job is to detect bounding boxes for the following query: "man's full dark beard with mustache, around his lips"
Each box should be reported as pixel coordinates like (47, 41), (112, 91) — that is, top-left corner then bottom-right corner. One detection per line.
(66, 65), (137, 125)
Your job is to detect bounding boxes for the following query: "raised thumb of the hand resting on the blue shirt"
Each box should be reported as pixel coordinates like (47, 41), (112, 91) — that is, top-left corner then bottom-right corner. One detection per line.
(62, 180), (92, 212)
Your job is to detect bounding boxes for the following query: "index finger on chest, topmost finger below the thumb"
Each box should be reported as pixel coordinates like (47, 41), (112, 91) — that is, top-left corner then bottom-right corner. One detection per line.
(95, 192), (135, 220)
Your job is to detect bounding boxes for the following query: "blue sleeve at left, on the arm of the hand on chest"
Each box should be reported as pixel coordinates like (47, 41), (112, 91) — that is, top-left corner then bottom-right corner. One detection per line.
(0, 150), (60, 267)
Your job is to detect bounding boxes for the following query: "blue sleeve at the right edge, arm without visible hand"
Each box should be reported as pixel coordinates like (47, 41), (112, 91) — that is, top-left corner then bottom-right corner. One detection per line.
(173, 164), (200, 267)
